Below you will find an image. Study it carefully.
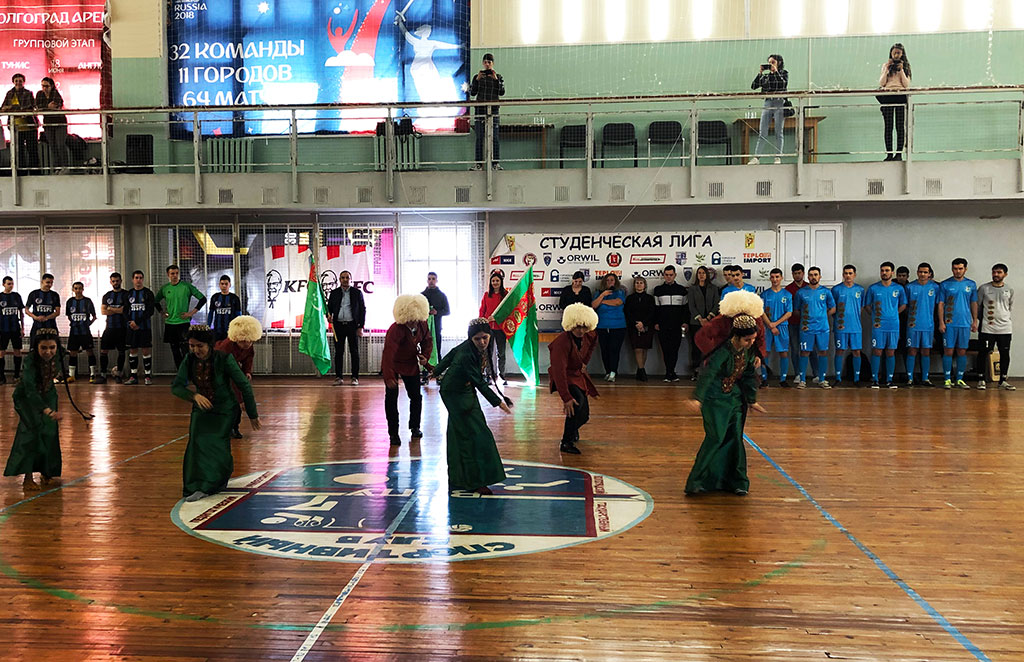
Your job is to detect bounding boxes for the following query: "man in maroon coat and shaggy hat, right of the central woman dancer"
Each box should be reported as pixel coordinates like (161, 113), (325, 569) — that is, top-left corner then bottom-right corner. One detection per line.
(548, 303), (598, 455)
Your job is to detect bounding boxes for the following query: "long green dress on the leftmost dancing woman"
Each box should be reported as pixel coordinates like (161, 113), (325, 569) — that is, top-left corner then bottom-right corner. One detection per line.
(3, 351), (60, 478)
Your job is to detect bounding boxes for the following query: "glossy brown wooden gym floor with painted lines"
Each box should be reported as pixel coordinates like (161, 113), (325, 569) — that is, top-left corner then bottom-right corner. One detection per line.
(0, 378), (1024, 662)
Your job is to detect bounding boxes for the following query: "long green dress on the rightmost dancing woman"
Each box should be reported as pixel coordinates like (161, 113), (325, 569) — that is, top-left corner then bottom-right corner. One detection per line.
(686, 341), (758, 494)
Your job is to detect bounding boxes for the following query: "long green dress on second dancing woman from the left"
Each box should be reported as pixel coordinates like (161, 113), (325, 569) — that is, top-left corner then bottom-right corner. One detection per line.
(171, 350), (259, 496)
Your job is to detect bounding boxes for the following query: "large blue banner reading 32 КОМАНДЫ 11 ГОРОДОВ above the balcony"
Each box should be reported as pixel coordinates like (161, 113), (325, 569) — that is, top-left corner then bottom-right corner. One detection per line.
(167, 0), (469, 135)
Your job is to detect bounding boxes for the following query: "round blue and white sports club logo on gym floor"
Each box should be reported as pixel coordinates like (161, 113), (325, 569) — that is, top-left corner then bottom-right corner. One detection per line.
(171, 458), (653, 564)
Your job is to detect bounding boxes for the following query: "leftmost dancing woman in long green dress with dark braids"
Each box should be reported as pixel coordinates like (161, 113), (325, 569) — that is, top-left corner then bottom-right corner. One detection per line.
(3, 329), (60, 492)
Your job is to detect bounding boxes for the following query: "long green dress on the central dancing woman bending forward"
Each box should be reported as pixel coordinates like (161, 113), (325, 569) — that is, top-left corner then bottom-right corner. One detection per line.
(434, 340), (505, 490)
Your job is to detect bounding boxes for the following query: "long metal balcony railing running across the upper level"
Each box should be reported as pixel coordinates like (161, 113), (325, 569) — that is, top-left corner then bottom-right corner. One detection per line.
(0, 86), (1024, 205)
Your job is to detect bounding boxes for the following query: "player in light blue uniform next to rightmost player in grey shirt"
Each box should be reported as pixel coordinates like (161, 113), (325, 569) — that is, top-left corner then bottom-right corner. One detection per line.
(939, 257), (978, 388)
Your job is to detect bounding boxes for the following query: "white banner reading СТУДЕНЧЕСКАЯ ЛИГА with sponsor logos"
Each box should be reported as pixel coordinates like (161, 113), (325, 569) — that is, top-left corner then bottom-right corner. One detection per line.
(489, 231), (777, 320)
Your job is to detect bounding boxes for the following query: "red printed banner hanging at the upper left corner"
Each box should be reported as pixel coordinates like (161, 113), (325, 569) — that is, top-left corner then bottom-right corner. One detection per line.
(0, 0), (104, 138)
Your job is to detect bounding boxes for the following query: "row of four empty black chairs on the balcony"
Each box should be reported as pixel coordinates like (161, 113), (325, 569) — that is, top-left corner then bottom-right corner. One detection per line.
(558, 120), (732, 168)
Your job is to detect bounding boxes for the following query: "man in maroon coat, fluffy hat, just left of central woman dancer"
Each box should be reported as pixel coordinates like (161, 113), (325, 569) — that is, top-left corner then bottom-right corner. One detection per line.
(381, 294), (434, 446)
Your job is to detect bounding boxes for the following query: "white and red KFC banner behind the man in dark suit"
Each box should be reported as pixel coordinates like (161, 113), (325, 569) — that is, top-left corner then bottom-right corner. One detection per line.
(263, 237), (396, 331)
